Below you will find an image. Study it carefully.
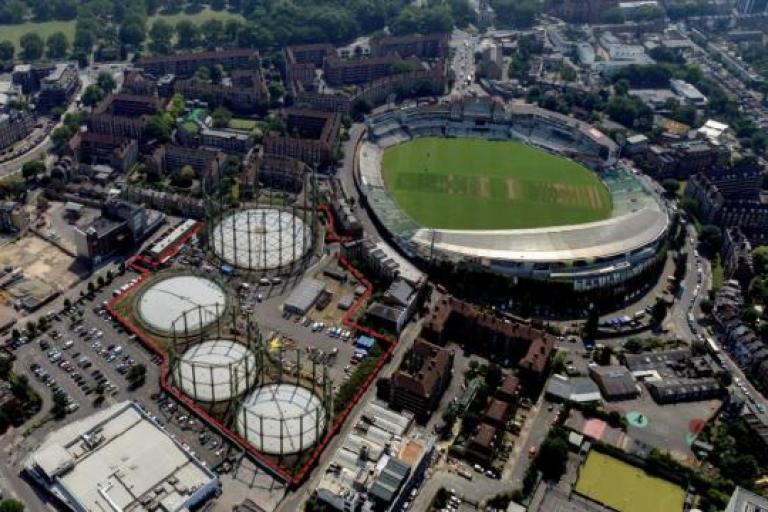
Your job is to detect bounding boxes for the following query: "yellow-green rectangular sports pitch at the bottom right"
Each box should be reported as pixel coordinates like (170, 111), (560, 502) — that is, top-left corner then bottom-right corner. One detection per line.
(576, 450), (685, 512)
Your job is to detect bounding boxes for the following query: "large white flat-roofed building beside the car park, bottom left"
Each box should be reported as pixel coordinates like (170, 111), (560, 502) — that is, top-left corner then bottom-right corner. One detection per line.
(25, 402), (220, 512)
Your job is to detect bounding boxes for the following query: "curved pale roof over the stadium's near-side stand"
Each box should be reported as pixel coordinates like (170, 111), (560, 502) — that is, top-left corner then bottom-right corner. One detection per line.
(412, 208), (668, 262)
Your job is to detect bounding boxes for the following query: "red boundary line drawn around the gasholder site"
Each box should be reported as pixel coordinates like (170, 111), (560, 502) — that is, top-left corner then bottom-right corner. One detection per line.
(107, 214), (397, 487)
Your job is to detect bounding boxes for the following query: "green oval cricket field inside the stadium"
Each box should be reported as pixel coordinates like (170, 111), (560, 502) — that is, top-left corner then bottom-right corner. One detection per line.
(382, 137), (611, 230)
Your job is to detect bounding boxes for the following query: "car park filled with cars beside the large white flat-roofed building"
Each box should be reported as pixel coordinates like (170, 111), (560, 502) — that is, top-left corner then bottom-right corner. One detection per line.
(4, 271), (242, 470)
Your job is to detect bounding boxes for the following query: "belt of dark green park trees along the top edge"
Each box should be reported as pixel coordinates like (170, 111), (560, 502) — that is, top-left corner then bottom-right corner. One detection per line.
(0, 0), (486, 61)
